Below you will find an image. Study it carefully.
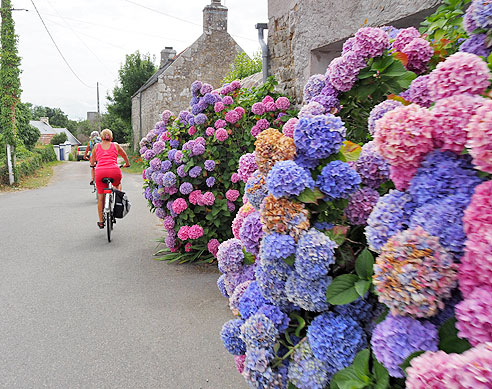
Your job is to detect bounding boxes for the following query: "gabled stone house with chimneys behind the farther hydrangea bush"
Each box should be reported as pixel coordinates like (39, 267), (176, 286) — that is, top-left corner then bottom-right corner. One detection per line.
(132, 0), (243, 146)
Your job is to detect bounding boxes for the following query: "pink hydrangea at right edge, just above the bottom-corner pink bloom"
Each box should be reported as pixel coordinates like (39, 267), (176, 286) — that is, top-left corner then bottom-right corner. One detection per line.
(455, 285), (492, 346)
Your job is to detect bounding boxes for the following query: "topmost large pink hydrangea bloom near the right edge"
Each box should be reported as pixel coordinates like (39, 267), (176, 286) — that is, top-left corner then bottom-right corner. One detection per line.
(429, 52), (490, 100)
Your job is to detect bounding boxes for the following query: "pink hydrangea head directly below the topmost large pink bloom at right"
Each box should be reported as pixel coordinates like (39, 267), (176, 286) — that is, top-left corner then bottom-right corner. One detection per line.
(431, 94), (484, 154)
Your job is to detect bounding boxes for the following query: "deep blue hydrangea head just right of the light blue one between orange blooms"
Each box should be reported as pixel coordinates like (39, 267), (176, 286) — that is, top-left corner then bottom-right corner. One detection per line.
(316, 161), (361, 201)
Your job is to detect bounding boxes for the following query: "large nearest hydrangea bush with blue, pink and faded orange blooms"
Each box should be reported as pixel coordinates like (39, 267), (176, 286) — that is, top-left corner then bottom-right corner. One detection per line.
(218, 5), (492, 389)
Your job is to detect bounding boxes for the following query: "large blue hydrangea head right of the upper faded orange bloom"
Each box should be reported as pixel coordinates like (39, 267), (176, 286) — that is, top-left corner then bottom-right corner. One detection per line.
(294, 114), (346, 165)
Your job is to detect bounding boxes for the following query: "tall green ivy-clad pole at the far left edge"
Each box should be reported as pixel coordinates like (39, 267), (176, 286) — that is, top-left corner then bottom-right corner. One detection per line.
(0, 0), (21, 183)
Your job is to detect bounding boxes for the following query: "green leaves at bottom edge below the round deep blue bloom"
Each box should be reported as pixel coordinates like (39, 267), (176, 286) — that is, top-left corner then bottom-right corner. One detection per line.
(330, 349), (390, 389)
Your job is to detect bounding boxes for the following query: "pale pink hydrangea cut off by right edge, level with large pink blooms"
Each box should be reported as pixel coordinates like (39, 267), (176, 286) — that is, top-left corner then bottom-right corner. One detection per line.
(466, 100), (492, 173)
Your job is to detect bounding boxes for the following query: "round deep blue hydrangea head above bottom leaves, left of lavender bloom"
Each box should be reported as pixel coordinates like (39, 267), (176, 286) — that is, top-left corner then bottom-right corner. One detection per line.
(307, 312), (367, 374)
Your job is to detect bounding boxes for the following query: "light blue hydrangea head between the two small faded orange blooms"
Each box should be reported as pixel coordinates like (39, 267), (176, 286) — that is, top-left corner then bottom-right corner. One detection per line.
(267, 161), (314, 198)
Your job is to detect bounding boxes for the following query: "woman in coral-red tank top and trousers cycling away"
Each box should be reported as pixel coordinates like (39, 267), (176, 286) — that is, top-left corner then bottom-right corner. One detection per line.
(90, 128), (130, 229)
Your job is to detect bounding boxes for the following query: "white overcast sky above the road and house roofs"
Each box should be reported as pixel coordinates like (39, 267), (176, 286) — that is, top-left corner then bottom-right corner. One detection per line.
(12, 0), (268, 120)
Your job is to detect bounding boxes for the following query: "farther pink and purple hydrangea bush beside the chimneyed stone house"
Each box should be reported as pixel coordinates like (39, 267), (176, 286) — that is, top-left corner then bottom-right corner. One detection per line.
(140, 79), (293, 262)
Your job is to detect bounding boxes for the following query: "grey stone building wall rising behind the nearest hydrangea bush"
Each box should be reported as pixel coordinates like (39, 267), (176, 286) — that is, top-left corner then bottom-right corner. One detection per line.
(268, 0), (441, 103)
